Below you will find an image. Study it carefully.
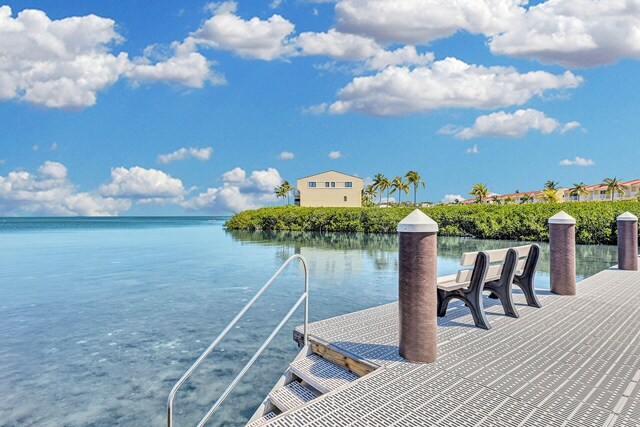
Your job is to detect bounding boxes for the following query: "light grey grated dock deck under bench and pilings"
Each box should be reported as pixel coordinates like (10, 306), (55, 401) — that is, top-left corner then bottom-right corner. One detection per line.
(267, 269), (640, 427)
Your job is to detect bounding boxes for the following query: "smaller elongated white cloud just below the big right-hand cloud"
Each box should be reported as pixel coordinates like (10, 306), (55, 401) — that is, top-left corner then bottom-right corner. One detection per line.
(441, 108), (580, 139)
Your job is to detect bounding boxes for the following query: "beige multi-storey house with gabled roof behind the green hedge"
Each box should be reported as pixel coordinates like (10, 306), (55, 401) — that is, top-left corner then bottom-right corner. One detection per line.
(295, 171), (364, 207)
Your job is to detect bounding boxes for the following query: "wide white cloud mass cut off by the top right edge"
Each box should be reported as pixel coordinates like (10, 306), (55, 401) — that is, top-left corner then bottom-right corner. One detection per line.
(335, 0), (640, 67)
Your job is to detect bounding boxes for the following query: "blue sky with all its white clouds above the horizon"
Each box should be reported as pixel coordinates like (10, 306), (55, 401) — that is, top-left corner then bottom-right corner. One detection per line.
(0, 0), (640, 216)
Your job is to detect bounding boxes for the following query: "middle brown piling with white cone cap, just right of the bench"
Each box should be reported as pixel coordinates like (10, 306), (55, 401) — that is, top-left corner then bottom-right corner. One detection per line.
(549, 211), (576, 295)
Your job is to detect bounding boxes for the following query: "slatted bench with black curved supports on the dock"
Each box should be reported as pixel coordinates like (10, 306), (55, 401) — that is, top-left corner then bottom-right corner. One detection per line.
(438, 245), (541, 329)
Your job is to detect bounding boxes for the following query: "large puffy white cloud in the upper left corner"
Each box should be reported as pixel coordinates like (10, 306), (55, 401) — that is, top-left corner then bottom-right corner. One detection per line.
(0, 6), (129, 108)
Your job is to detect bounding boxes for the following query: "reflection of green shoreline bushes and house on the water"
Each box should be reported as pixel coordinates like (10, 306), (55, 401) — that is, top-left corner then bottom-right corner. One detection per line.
(227, 230), (617, 279)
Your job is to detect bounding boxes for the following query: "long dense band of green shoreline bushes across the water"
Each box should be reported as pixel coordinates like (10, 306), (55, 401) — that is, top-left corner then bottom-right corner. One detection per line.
(225, 200), (640, 245)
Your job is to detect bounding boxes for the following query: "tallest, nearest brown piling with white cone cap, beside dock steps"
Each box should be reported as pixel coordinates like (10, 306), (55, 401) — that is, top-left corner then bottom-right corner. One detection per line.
(398, 209), (438, 363)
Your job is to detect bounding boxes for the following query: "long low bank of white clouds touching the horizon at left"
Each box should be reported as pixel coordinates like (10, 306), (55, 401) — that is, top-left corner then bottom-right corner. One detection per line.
(0, 161), (282, 216)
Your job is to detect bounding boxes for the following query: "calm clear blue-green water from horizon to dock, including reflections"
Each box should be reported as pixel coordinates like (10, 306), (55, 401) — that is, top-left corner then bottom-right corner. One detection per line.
(0, 217), (616, 426)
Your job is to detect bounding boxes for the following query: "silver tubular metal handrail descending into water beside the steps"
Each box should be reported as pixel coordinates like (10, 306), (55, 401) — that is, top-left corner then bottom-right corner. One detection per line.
(167, 254), (309, 427)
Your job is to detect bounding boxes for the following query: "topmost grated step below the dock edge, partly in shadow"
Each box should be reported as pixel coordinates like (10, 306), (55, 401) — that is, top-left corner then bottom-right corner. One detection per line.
(290, 354), (358, 394)
